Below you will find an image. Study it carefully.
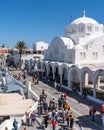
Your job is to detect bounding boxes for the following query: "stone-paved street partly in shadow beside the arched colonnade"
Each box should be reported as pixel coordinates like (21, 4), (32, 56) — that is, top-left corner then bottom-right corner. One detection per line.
(8, 69), (104, 130)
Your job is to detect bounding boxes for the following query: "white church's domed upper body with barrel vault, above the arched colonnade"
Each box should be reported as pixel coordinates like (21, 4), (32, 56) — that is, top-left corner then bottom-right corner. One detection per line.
(45, 12), (104, 64)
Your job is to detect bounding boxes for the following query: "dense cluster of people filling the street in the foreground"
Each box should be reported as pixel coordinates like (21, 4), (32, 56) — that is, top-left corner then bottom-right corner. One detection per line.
(38, 89), (75, 130)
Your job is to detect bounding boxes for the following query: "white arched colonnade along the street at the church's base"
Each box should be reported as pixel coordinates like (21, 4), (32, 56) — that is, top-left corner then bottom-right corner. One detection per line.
(26, 61), (104, 97)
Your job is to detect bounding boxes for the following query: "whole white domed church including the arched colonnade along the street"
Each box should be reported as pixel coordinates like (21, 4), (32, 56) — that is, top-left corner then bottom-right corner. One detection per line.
(27, 11), (104, 102)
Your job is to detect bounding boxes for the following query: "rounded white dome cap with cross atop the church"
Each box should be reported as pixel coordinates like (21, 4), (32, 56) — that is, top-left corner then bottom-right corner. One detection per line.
(71, 11), (99, 24)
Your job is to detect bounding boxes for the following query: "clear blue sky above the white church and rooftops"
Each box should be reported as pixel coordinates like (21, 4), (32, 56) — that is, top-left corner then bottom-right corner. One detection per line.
(0, 0), (104, 47)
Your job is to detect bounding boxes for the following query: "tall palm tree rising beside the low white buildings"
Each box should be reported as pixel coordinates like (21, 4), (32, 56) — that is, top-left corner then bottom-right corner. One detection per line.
(16, 41), (27, 69)
